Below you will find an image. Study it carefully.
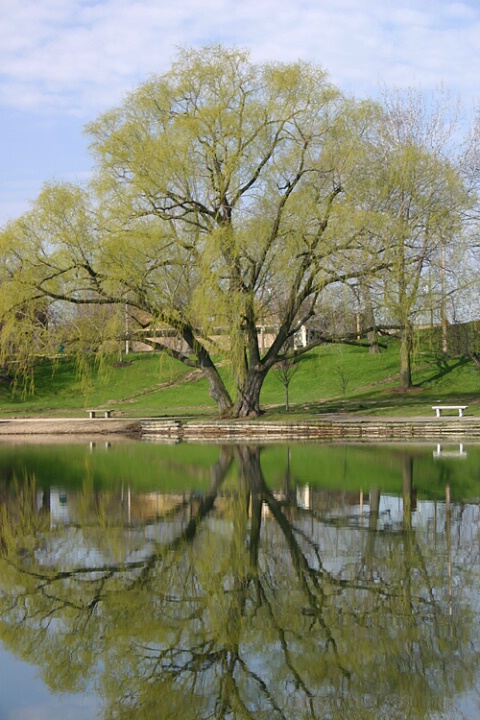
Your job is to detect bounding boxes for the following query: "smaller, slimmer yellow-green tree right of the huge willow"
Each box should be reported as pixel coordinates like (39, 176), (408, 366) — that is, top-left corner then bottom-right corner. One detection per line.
(356, 90), (473, 389)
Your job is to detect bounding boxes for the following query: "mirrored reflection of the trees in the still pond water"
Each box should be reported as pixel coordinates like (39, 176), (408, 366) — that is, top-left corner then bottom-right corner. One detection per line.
(0, 446), (479, 720)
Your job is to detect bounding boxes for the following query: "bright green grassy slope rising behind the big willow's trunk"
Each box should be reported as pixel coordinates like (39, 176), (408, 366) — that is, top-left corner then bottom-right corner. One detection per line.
(0, 340), (480, 421)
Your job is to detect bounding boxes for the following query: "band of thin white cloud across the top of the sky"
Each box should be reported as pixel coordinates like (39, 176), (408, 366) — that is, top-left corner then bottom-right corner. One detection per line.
(0, 0), (480, 117)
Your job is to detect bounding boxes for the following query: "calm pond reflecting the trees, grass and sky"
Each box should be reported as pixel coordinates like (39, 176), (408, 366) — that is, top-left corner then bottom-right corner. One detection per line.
(0, 440), (480, 720)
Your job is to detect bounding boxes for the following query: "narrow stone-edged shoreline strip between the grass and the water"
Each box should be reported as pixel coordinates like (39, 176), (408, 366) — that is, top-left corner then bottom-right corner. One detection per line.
(0, 414), (480, 443)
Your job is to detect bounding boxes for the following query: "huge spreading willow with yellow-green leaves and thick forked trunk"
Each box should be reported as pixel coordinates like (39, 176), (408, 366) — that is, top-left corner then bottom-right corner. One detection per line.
(0, 46), (378, 416)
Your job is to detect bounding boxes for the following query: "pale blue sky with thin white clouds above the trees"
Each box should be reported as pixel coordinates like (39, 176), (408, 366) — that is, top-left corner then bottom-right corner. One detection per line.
(0, 0), (480, 227)
